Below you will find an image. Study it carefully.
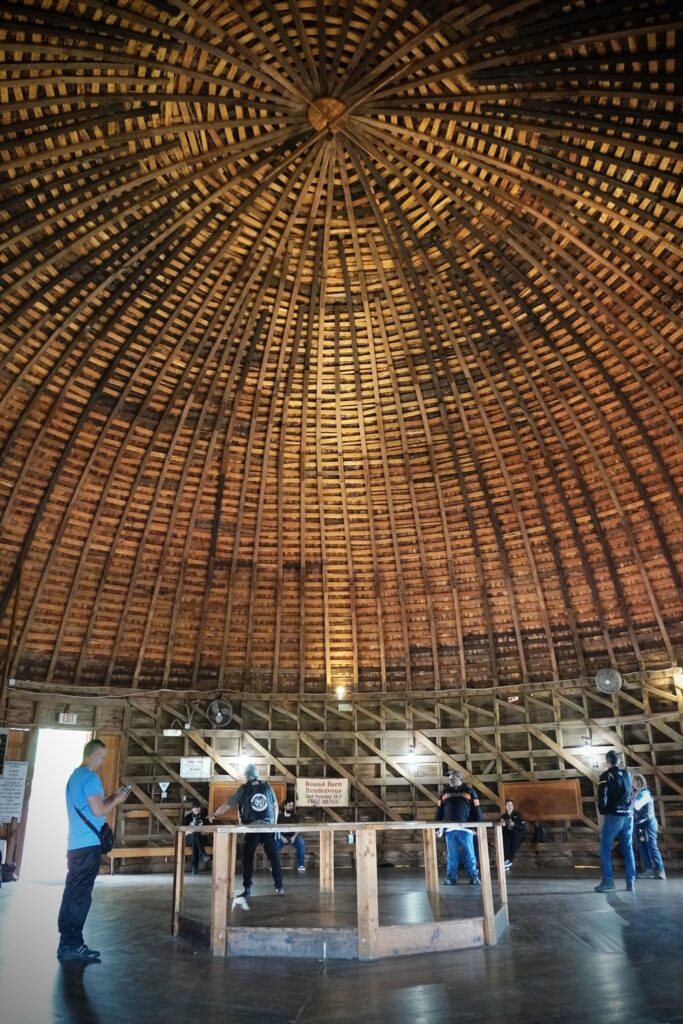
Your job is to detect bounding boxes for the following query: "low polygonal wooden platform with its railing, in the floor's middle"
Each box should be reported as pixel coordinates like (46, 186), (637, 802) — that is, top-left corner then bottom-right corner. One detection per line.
(172, 821), (509, 961)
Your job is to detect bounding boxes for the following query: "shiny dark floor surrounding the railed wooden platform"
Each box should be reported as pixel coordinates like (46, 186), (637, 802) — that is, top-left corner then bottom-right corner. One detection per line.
(0, 868), (683, 1024)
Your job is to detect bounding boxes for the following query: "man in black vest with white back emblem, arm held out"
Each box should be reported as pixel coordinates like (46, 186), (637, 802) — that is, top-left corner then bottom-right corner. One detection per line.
(210, 765), (285, 896)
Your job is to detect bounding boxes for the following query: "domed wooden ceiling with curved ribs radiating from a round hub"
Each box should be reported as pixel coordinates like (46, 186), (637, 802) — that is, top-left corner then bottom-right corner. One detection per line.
(0, 0), (683, 693)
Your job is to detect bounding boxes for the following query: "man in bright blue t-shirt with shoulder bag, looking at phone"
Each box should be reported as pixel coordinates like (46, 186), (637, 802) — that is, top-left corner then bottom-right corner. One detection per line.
(57, 739), (129, 964)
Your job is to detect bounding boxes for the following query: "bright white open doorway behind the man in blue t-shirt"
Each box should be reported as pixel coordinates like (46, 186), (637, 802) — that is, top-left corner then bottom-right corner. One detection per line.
(20, 729), (92, 882)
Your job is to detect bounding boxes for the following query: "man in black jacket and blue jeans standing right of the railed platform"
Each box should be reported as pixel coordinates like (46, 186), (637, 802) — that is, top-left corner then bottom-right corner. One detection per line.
(595, 751), (636, 893)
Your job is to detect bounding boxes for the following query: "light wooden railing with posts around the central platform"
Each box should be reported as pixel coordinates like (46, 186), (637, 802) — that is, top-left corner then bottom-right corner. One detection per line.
(171, 821), (509, 959)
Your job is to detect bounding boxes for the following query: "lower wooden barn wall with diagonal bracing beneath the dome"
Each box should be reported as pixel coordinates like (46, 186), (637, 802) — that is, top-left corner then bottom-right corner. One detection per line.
(0, 673), (683, 869)
